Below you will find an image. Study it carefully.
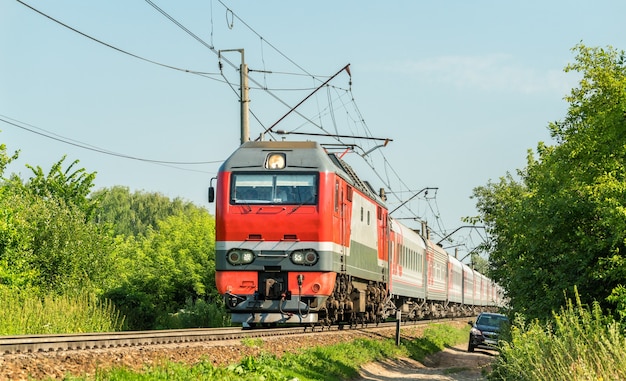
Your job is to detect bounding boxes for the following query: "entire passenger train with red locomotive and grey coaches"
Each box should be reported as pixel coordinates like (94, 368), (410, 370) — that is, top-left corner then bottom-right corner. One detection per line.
(209, 141), (503, 327)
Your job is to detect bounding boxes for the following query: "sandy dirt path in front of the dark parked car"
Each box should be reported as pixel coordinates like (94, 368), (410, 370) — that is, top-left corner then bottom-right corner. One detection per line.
(355, 344), (496, 381)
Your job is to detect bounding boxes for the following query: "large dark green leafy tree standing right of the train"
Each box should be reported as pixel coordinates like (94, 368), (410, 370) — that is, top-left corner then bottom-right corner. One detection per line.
(474, 44), (626, 318)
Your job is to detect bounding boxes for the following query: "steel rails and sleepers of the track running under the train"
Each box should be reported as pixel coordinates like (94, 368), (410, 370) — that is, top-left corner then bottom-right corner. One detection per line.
(0, 318), (453, 355)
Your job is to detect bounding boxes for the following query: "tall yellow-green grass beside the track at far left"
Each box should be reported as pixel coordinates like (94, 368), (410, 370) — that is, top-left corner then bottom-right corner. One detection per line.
(0, 287), (123, 335)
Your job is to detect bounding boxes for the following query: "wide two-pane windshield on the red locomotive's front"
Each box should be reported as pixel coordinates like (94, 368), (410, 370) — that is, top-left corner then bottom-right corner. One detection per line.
(230, 173), (318, 205)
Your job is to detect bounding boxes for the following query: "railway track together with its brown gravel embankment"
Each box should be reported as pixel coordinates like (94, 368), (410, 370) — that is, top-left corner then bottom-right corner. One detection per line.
(0, 318), (467, 380)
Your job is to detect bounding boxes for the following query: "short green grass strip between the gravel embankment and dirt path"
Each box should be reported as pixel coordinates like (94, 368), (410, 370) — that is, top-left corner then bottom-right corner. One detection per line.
(61, 324), (467, 381)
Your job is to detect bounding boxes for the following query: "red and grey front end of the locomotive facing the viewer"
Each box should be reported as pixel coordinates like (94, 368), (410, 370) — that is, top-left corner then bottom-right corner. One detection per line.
(215, 142), (336, 326)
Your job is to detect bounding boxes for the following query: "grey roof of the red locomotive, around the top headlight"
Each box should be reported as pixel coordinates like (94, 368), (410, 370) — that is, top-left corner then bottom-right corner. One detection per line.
(220, 141), (383, 204)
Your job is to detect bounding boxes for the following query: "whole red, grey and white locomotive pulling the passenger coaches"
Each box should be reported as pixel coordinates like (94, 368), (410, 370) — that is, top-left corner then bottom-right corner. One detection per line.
(210, 141), (388, 325)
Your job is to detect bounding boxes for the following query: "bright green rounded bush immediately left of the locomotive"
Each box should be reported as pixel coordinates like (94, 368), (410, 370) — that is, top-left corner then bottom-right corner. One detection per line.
(105, 207), (223, 329)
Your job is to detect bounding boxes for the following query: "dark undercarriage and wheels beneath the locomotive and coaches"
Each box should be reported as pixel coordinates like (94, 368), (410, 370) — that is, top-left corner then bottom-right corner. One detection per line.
(226, 274), (489, 327)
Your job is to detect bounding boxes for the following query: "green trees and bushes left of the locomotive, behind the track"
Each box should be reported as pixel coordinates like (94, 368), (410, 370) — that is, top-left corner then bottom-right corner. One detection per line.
(0, 144), (228, 334)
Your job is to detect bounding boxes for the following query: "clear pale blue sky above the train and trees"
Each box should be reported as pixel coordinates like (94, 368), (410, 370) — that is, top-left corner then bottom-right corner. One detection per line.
(0, 0), (626, 254)
